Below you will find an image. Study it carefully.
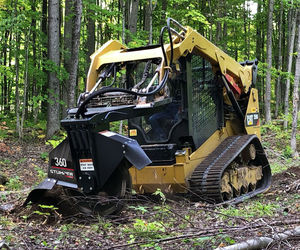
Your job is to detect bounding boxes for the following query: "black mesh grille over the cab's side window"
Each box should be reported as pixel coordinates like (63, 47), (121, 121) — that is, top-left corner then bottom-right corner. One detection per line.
(191, 55), (218, 146)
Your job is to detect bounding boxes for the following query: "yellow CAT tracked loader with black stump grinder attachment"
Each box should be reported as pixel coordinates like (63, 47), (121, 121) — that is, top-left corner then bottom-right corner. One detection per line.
(26, 18), (271, 214)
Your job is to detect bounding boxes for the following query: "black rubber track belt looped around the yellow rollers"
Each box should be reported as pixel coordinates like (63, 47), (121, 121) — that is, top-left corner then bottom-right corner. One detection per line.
(189, 135), (271, 204)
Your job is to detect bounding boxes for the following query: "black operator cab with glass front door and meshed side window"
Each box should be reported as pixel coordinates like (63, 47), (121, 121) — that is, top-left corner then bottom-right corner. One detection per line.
(128, 53), (224, 165)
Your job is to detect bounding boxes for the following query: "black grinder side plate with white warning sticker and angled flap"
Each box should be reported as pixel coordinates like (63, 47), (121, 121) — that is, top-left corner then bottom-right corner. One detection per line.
(64, 129), (151, 193)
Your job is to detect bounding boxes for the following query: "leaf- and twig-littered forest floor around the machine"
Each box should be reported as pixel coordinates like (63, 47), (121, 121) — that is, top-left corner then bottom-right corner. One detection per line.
(0, 124), (300, 249)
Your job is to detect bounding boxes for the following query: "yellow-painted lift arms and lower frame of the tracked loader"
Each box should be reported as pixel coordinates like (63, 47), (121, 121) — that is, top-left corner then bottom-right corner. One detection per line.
(86, 24), (260, 196)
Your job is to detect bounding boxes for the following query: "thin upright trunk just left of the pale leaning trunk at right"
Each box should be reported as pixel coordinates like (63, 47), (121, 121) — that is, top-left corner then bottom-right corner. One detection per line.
(275, 0), (283, 118)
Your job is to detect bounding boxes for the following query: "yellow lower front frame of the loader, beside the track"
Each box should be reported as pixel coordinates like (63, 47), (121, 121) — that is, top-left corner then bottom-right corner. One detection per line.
(129, 122), (234, 193)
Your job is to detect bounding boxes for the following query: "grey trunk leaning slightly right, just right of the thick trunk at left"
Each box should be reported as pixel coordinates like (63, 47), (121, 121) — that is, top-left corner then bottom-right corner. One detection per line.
(68, 0), (82, 108)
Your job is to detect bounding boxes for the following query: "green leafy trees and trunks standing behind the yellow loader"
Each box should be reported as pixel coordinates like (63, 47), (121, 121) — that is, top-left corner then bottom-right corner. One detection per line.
(0, 0), (300, 157)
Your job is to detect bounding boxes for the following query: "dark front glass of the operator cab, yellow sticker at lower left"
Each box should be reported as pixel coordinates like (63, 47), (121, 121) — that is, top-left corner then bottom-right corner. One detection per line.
(128, 57), (188, 145)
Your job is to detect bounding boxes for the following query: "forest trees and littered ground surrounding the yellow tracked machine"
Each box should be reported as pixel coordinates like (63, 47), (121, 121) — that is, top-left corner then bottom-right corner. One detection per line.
(0, 0), (300, 249)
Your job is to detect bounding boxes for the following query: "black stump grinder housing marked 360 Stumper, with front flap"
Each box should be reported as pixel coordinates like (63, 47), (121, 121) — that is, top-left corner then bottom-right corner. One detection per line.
(24, 130), (151, 205)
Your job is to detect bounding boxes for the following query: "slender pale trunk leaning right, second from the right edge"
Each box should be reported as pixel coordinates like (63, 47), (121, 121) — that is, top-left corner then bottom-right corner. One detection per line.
(283, 11), (298, 129)
